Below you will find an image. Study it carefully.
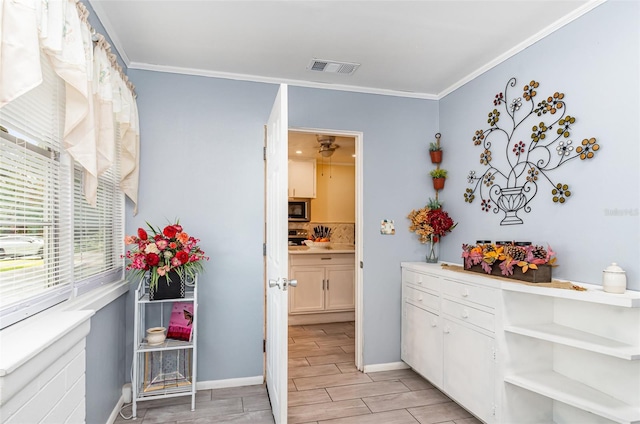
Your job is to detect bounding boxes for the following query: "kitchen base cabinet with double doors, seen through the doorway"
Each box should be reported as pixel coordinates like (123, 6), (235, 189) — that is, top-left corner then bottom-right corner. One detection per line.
(289, 253), (355, 314)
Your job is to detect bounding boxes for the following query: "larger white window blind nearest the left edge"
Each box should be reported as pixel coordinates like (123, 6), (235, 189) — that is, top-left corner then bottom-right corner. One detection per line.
(0, 56), (72, 327)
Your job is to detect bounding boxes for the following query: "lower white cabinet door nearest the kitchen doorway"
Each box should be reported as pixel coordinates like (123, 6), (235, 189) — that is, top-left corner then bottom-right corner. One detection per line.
(401, 302), (442, 387)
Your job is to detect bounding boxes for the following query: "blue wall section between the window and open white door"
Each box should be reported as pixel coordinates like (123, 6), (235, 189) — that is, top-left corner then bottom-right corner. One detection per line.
(127, 70), (278, 381)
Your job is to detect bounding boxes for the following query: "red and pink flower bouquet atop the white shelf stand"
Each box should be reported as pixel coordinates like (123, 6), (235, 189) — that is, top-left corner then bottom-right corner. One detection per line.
(124, 223), (209, 289)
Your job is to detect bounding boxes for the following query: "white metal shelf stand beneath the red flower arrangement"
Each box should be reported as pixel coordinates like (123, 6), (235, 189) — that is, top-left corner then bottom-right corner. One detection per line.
(131, 275), (198, 418)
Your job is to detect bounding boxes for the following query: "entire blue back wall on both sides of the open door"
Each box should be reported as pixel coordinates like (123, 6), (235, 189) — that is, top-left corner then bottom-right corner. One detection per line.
(127, 70), (437, 381)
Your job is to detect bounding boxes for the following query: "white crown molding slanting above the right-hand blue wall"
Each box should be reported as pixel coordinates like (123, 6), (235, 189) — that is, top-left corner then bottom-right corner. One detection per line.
(436, 0), (607, 100)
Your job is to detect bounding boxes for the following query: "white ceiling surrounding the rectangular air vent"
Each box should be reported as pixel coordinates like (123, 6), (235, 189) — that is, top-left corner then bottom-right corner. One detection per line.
(89, 0), (604, 99)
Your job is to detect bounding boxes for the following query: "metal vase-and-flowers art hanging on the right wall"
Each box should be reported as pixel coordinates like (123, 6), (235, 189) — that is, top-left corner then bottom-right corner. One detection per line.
(464, 78), (600, 225)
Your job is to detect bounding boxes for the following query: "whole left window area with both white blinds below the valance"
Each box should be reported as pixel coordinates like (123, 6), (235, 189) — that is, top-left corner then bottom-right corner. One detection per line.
(0, 51), (124, 328)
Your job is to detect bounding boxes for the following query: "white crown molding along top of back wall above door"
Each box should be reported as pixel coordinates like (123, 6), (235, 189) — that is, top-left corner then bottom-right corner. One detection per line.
(127, 62), (437, 100)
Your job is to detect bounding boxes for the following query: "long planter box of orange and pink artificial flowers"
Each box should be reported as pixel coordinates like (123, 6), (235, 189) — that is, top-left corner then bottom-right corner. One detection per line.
(462, 243), (556, 283)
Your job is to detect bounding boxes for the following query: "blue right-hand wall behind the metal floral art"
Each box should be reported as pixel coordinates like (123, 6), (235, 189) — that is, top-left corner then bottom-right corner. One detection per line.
(440, 1), (640, 290)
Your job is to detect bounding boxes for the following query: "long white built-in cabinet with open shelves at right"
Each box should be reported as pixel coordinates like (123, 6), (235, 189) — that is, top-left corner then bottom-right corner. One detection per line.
(401, 262), (640, 424)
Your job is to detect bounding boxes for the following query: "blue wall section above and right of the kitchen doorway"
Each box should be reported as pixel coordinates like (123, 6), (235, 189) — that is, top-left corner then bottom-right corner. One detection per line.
(289, 87), (438, 365)
